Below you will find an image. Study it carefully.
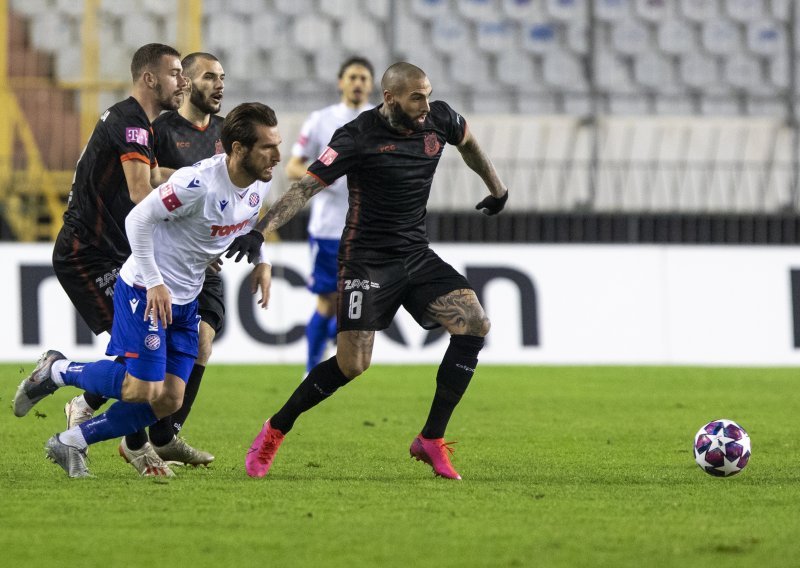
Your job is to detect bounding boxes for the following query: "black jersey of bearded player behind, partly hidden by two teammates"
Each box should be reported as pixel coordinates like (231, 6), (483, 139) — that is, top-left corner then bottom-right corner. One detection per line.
(153, 110), (224, 170)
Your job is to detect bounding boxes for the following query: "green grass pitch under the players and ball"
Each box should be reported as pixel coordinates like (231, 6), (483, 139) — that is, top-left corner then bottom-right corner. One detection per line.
(0, 363), (800, 568)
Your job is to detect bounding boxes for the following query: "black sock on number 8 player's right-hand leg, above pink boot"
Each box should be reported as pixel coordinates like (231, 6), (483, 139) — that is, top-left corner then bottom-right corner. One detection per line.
(422, 335), (484, 438)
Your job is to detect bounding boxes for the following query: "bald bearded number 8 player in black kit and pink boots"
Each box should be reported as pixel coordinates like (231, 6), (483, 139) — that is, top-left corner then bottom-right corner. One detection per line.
(226, 63), (508, 479)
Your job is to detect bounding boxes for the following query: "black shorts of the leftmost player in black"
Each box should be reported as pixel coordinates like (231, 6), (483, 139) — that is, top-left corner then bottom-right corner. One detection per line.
(53, 225), (122, 335)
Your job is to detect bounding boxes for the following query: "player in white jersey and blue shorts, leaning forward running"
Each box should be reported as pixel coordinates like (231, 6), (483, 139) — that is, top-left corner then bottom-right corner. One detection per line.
(13, 103), (281, 477)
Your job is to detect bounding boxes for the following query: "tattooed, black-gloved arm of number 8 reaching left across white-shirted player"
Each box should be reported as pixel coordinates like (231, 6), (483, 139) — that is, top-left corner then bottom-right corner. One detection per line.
(225, 175), (326, 264)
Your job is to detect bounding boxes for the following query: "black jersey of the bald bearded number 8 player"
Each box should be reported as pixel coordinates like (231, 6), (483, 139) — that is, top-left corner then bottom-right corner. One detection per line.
(308, 101), (467, 260)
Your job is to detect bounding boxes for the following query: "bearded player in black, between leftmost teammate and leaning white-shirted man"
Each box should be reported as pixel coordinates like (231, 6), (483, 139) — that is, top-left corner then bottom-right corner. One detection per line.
(65, 52), (225, 475)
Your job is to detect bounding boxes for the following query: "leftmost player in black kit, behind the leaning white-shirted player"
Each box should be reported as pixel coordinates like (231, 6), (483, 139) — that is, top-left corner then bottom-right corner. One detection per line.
(53, 43), (186, 475)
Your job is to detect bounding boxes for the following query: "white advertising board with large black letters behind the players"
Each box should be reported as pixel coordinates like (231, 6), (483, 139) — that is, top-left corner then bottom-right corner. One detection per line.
(0, 244), (800, 365)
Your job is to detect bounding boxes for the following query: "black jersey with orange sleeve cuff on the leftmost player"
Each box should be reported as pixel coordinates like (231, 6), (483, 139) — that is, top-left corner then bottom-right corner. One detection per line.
(64, 97), (157, 264)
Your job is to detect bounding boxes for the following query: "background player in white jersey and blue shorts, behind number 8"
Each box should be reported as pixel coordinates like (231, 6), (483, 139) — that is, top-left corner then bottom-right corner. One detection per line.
(286, 57), (375, 373)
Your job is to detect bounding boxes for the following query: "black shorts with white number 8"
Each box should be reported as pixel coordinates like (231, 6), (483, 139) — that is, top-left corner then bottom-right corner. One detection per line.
(337, 248), (472, 331)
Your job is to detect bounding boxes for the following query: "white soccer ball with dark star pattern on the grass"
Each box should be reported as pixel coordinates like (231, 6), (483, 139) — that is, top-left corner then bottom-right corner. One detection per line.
(694, 418), (750, 477)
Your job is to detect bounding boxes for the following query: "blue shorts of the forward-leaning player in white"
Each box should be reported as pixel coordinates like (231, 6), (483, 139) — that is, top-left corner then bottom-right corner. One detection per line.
(106, 278), (200, 382)
